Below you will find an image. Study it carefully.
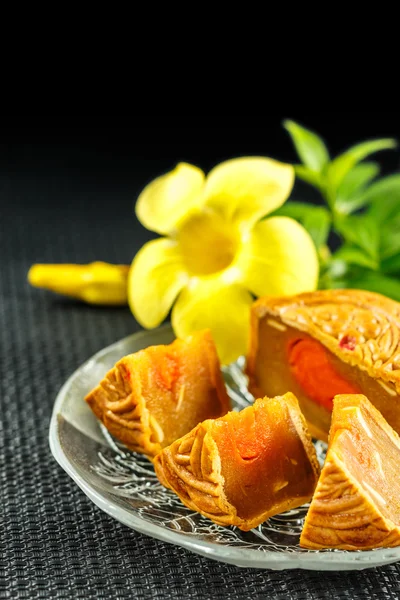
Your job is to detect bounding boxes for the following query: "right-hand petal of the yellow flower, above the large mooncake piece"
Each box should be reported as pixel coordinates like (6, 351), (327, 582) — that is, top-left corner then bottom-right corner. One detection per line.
(236, 217), (318, 296)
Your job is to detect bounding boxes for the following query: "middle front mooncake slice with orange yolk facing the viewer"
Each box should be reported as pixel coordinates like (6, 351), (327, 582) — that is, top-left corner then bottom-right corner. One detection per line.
(154, 393), (319, 531)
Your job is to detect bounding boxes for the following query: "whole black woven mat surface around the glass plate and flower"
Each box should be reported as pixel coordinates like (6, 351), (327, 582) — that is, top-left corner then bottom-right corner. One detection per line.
(0, 113), (400, 600)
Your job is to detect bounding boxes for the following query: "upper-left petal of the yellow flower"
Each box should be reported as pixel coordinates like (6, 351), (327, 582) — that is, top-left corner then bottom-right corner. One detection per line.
(136, 163), (205, 234)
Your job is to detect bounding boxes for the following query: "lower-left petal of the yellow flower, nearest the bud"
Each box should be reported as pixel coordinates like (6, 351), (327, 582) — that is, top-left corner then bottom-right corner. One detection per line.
(128, 238), (188, 329)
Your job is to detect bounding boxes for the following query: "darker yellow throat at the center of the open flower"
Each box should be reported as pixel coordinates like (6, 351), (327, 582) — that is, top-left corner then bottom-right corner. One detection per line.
(177, 211), (239, 275)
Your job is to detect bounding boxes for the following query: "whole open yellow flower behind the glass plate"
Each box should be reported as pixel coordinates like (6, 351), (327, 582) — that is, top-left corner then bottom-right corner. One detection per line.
(128, 157), (318, 364)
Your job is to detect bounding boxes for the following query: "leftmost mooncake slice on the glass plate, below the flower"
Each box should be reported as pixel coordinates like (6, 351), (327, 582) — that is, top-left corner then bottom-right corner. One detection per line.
(85, 330), (230, 457)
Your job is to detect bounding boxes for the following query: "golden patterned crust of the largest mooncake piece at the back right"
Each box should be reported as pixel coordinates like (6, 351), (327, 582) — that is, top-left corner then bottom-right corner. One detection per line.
(246, 290), (400, 394)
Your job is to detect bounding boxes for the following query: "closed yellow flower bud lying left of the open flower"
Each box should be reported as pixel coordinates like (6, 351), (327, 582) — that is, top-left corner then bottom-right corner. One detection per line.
(28, 262), (129, 305)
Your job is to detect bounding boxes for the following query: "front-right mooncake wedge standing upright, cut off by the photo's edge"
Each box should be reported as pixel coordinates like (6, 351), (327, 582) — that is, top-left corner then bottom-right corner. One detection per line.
(300, 395), (400, 550)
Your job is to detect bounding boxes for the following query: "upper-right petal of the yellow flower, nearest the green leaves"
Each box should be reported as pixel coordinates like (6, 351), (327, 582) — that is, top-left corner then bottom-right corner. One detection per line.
(204, 157), (294, 229)
